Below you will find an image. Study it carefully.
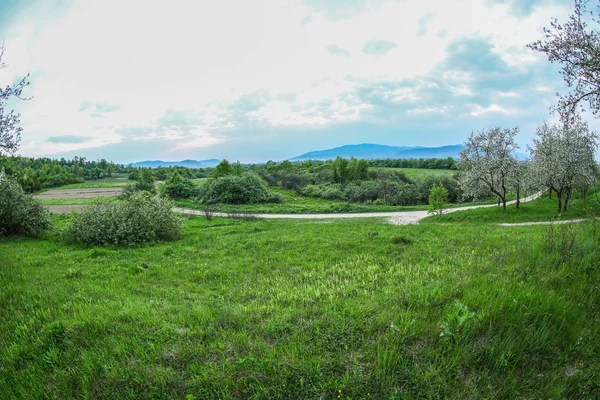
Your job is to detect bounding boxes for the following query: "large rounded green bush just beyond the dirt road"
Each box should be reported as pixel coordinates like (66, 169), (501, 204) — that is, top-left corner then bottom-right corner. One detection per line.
(202, 173), (283, 204)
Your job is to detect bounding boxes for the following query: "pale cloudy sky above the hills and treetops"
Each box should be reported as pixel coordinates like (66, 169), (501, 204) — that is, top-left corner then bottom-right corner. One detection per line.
(0, 0), (598, 163)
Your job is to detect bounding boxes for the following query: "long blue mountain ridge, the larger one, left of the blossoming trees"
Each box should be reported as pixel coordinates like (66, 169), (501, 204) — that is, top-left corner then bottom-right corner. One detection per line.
(290, 143), (463, 161)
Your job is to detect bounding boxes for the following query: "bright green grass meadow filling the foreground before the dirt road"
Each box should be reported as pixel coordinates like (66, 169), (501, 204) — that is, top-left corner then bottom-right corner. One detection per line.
(0, 217), (600, 399)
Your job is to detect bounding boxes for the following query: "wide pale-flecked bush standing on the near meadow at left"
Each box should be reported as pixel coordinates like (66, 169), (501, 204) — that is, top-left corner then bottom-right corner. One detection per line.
(66, 192), (181, 247)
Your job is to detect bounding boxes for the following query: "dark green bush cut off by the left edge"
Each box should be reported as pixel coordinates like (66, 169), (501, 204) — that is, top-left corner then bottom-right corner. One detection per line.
(0, 176), (50, 236)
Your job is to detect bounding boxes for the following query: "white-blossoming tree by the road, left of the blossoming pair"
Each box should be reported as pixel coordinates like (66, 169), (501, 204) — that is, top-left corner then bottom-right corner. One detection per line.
(459, 127), (519, 209)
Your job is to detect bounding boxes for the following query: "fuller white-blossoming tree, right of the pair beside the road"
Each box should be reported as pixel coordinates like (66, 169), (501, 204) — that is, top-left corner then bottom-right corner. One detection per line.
(529, 115), (598, 212)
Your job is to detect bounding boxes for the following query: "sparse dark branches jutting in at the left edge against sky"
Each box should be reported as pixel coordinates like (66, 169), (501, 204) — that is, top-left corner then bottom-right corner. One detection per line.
(0, 46), (29, 155)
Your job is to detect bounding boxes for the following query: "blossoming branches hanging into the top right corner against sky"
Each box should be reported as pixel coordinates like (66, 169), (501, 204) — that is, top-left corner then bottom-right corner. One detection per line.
(527, 0), (600, 117)
